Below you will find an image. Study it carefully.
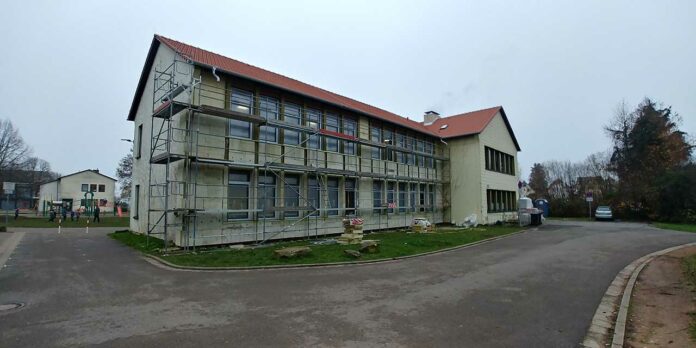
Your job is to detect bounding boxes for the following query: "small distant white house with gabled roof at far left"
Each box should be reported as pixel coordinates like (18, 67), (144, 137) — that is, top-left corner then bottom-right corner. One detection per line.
(38, 169), (116, 212)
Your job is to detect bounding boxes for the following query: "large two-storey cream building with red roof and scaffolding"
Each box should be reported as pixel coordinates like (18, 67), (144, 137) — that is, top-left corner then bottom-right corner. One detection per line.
(128, 35), (519, 246)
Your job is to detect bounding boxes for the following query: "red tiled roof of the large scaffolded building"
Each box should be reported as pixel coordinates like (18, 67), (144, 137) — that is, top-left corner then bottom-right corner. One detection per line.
(128, 35), (519, 149)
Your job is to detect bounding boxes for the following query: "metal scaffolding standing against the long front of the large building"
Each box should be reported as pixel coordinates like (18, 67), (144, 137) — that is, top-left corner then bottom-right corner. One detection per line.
(145, 59), (449, 249)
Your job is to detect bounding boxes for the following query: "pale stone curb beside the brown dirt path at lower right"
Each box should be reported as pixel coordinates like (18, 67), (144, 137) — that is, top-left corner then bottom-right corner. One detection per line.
(580, 243), (696, 348)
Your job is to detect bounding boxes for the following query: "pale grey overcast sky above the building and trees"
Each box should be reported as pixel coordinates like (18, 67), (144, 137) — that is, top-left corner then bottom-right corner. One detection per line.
(0, 0), (696, 182)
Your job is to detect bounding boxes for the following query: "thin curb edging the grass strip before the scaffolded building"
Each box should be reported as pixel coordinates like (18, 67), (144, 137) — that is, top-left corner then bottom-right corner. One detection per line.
(142, 228), (538, 272)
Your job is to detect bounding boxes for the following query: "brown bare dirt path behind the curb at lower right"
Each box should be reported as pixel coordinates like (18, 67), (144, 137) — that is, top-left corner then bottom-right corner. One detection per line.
(624, 247), (696, 347)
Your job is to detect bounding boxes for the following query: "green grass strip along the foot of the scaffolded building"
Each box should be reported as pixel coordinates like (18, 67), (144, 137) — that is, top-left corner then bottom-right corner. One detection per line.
(109, 226), (522, 267)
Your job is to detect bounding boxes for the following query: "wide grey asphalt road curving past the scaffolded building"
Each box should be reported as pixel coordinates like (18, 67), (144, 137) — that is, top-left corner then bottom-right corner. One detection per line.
(0, 222), (696, 348)
